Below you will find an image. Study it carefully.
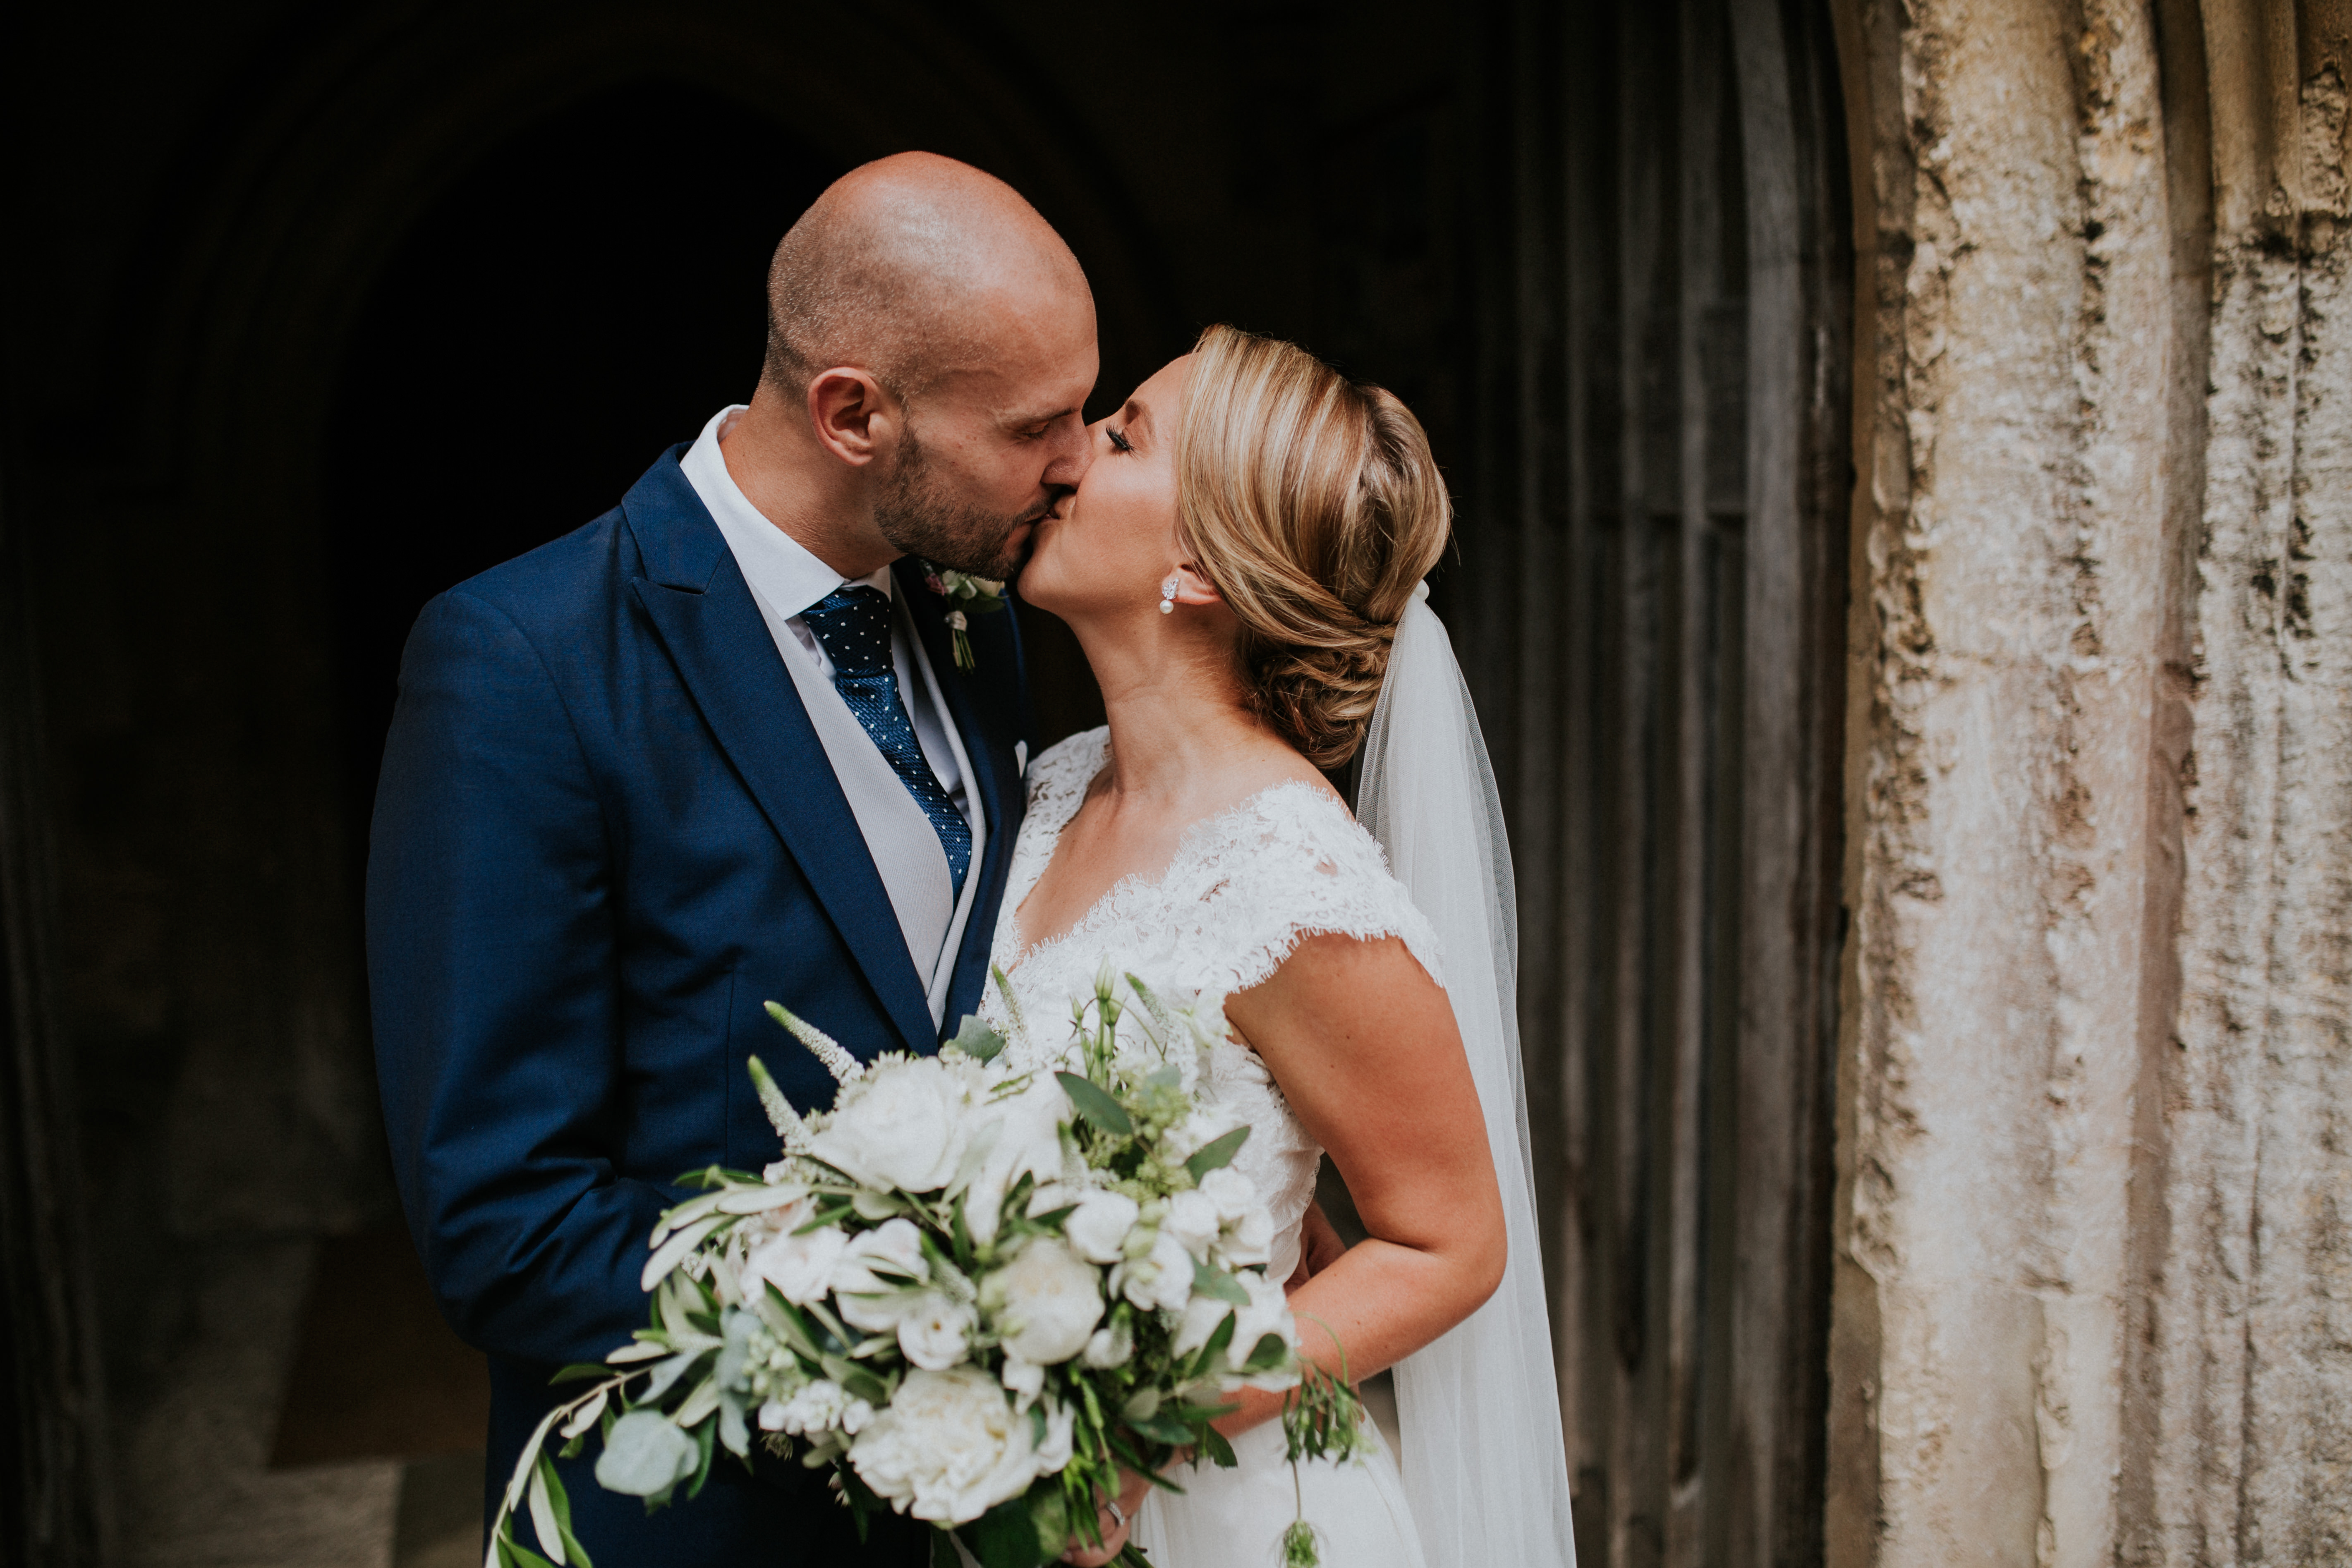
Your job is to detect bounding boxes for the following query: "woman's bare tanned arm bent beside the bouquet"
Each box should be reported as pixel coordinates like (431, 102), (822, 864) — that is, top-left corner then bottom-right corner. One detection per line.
(1216, 936), (1505, 1434)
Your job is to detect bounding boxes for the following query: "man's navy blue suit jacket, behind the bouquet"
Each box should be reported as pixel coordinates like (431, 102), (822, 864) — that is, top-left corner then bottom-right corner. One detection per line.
(367, 447), (1028, 1568)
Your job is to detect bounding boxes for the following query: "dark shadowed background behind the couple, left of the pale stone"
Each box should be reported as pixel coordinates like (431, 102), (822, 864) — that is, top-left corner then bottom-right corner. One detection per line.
(0, 0), (1844, 1568)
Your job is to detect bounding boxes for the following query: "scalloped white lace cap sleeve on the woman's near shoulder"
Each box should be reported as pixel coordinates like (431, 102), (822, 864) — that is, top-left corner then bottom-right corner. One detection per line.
(1169, 783), (1447, 992)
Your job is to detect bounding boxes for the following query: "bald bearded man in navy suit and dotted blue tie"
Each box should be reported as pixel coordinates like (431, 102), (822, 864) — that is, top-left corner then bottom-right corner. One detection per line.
(367, 153), (1096, 1568)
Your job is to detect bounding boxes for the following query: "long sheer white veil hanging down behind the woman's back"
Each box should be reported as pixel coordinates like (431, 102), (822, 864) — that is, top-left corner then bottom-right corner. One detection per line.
(1357, 583), (1576, 1568)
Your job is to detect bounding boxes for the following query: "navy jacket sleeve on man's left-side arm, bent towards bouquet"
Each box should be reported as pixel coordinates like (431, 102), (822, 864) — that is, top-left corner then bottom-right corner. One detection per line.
(367, 592), (680, 1364)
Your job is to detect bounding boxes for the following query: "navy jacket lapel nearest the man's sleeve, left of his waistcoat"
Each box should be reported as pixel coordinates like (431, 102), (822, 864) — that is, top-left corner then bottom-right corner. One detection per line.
(621, 460), (939, 1051)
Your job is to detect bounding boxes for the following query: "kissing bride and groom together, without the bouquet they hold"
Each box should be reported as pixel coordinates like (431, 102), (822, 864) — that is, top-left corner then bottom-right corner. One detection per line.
(367, 153), (1574, 1568)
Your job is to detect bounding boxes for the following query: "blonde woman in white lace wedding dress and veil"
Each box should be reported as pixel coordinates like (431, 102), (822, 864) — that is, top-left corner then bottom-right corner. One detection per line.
(990, 327), (1574, 1568)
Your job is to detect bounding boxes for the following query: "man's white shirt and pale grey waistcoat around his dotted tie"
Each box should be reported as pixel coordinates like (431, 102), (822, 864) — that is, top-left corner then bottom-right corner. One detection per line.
(680, 405), (988, 1022)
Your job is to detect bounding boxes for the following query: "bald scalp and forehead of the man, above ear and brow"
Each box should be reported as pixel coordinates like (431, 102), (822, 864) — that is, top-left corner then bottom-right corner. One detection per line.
(760, 153), (1094, 397)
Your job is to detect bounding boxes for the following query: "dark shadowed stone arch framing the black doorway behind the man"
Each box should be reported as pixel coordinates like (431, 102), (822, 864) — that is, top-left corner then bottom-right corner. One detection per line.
(91, 5), (1171, 1260)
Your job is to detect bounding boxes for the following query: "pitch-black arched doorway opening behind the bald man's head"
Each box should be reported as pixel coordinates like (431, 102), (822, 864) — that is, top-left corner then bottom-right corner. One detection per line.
(327, 82), (842, 865)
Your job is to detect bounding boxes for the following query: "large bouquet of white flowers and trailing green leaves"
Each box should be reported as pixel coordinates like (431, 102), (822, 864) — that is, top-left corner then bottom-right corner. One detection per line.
(484, 964), (1362, 1568)
